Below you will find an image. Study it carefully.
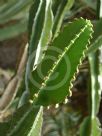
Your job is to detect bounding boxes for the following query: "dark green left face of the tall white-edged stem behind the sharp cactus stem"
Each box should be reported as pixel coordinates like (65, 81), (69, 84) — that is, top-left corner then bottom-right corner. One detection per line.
(25, 0), (46, 91)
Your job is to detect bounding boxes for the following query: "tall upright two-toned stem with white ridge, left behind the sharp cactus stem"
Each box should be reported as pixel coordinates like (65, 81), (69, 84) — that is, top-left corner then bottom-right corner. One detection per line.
(26, 0), (53, 90)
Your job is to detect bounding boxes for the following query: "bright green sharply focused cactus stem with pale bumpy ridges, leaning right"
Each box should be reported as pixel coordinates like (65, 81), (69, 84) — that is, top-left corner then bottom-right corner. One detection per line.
(29, 19), (92, 105)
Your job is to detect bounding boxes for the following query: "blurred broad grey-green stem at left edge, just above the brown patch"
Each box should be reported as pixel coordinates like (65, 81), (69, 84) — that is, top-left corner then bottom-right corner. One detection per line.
(0, 19), (27, 41)
